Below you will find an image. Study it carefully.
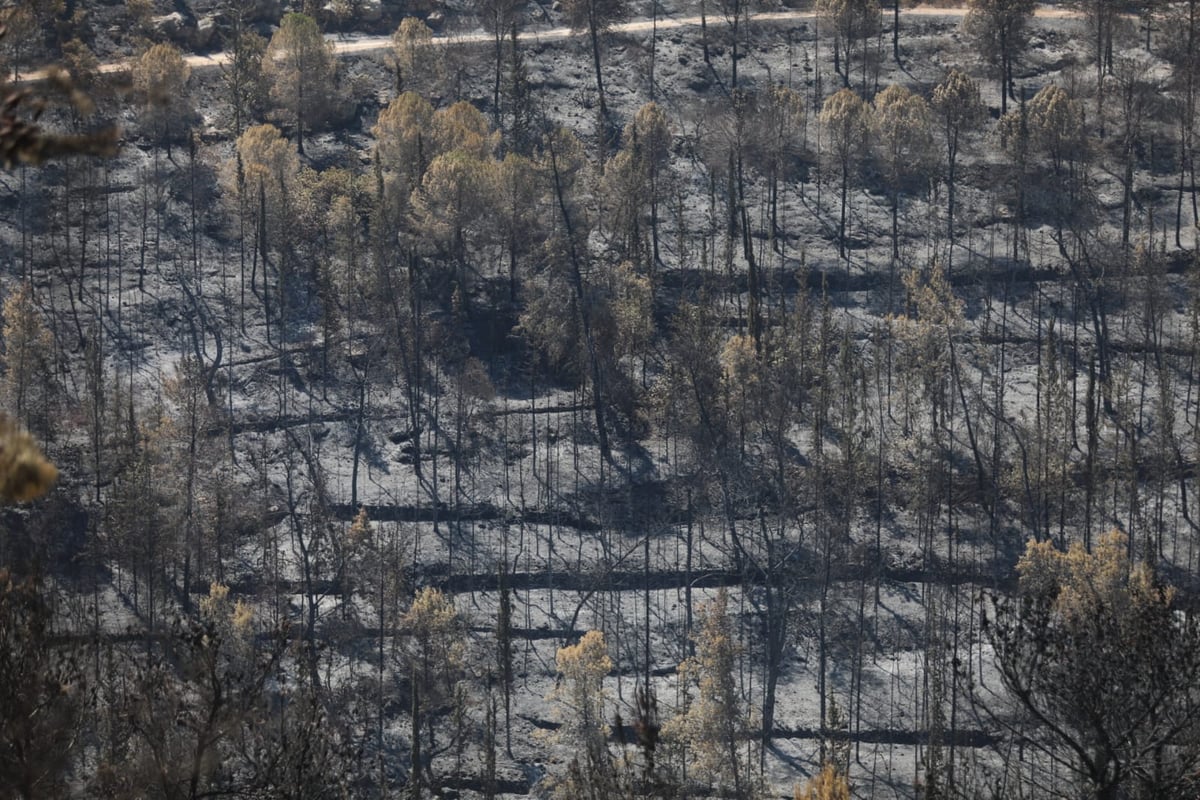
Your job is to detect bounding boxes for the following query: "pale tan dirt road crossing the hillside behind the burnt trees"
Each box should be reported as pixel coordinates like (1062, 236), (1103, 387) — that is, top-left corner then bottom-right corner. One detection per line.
(18, 6), (1079, 83)
